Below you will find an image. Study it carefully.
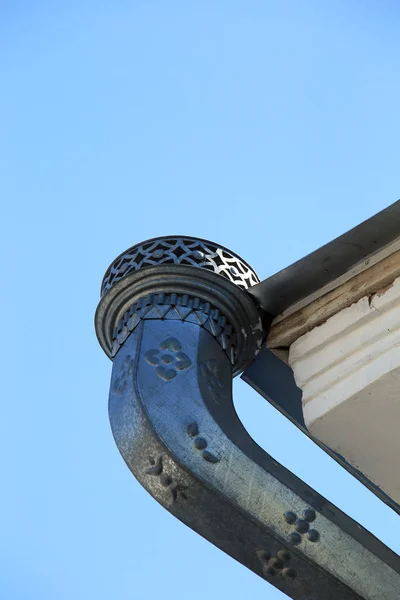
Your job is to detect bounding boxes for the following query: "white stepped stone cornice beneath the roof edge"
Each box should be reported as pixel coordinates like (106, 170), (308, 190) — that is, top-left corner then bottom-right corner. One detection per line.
(289, 278), (400, 502)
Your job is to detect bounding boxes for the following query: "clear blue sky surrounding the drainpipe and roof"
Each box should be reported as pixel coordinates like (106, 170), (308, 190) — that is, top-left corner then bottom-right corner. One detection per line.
(0, 0), (400, 600)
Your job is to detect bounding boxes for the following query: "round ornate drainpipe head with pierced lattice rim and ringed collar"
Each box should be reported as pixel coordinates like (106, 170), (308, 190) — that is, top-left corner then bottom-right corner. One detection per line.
(96, 236), (265, 375)
